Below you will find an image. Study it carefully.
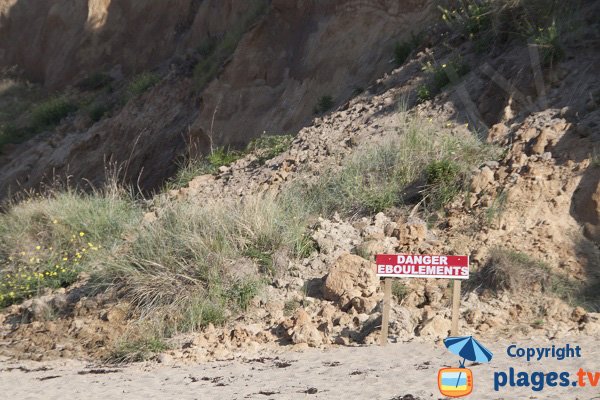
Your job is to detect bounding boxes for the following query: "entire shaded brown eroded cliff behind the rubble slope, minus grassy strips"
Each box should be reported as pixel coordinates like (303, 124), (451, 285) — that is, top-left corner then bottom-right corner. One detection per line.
(0, 0), (433, 198)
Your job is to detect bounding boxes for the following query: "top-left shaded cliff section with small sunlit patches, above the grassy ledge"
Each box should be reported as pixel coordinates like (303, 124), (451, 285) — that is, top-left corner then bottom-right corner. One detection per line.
(0, 0), (252, 89)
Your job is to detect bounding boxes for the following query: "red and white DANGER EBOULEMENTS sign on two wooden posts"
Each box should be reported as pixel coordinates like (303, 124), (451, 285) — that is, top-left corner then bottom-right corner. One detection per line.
(375, 254), (469, 346)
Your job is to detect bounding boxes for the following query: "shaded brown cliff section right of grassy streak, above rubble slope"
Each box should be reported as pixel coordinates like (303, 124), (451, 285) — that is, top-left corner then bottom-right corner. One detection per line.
(192, 0), (431, 148)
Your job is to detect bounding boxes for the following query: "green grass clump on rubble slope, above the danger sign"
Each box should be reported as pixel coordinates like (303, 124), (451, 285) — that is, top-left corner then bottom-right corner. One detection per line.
(290, 112), (495, 216)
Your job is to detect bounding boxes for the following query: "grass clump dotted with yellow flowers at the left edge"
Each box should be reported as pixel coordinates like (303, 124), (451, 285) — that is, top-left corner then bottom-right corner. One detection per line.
(0, 186), (141, 306)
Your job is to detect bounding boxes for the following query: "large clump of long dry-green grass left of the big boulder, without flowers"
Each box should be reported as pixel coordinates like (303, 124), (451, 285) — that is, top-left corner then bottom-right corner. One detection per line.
(99, 197), (304, 334)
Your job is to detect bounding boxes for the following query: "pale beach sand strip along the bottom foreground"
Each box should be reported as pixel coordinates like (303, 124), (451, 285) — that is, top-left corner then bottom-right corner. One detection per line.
(0, 337), (600, 400)
